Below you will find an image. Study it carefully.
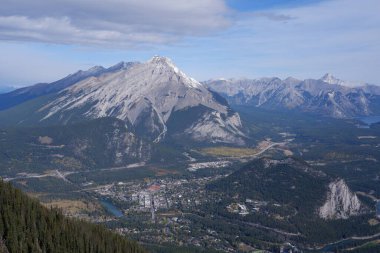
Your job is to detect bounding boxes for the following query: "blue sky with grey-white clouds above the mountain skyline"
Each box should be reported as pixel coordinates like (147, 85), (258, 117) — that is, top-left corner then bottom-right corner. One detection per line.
(0, 0), (380, 87)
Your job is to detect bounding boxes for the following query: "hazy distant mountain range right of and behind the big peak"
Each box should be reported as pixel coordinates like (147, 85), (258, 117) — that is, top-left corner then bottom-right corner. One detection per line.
(204, 74), (380, 118)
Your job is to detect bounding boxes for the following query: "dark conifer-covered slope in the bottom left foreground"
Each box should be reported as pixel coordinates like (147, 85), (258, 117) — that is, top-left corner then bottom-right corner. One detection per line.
(0, 181), (145, 253)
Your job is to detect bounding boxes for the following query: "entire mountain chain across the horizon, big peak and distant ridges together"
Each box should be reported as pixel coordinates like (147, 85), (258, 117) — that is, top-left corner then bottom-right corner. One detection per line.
(0, 56), (380, 145)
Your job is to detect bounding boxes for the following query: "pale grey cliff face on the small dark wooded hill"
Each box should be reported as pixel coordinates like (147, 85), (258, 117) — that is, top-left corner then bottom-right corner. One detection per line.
(319, 179), (363, 219)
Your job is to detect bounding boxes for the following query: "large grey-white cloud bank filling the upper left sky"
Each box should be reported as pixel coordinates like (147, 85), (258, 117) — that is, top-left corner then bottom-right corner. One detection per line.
(0, 0), (229, 47)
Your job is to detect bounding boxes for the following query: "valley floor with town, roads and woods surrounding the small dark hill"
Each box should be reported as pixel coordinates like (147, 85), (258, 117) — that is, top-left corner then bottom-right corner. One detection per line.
(0, 109), (380, 252)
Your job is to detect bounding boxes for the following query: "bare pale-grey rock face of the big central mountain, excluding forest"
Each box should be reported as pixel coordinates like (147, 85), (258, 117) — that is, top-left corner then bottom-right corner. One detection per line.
(40, 57), (244, 143)
